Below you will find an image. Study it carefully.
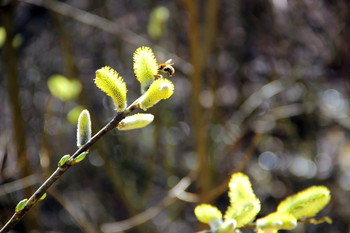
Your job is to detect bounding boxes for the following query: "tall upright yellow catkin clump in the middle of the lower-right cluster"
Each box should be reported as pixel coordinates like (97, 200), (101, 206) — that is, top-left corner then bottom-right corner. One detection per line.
(225, 173), (261, 228)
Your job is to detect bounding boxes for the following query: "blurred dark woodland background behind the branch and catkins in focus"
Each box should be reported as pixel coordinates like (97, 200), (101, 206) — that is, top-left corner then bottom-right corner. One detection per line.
(0, 0), (350, 233)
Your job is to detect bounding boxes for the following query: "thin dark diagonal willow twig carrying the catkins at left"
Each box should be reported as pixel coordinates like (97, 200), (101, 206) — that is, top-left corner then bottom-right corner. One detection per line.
(0, 105), (138, 233)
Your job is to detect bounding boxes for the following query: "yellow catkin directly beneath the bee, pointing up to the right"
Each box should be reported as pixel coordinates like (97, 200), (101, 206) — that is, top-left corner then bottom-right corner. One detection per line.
(138, 78), (174, 111)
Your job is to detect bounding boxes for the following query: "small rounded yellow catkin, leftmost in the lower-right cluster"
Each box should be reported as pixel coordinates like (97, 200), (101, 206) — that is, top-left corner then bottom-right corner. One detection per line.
(194, 204), (222, 230)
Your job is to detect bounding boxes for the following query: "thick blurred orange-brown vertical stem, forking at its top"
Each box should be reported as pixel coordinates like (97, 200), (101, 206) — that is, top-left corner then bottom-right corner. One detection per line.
(183, 0), (218, 202)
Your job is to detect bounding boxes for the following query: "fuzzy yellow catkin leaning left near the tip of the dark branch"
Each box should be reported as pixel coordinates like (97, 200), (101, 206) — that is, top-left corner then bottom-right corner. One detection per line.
(95, 66), (127, 112)
